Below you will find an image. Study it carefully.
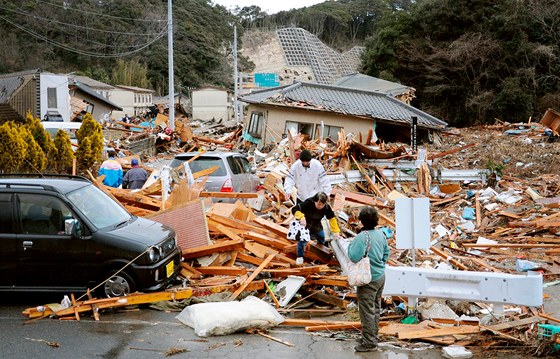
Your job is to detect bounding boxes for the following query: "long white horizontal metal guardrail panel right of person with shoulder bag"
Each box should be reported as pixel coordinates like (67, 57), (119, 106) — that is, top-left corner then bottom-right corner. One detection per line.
(383, 267), (543, 307)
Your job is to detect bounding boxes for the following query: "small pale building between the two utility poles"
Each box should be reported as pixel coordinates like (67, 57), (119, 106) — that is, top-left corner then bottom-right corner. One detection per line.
(192, 88), (229, 120)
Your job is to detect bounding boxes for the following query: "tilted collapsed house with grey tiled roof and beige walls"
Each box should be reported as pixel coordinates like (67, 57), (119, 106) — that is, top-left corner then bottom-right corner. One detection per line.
(240, 82), (447, 146)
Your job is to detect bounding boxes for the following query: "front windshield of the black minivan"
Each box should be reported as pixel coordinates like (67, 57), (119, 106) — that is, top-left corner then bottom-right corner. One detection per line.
(67, 185), (131, 229)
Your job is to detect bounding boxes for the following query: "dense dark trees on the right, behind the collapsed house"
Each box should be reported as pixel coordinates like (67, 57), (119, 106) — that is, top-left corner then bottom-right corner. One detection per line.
(358, 0), (560, 126)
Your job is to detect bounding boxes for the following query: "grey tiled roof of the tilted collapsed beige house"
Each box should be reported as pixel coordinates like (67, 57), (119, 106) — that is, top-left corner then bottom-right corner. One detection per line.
(240, 82), (447, 129)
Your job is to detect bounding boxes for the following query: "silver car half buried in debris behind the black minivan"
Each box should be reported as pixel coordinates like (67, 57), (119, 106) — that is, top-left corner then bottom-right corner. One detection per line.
(170, 151), (259, 197)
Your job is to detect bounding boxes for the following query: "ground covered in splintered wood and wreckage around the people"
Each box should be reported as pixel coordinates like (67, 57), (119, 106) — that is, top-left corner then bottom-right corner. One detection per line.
(24, 109), (560, 357)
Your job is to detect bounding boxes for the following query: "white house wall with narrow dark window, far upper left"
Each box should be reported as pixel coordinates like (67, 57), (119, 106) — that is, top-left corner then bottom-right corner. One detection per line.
(39, 73), (70, 121)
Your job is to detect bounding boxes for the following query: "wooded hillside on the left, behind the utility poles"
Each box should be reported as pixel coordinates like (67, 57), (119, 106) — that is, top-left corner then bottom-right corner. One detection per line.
(0, 0), (252, 94)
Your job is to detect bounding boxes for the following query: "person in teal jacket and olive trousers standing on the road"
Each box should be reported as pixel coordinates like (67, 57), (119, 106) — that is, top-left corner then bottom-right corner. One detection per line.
(348, 207), (389, 352)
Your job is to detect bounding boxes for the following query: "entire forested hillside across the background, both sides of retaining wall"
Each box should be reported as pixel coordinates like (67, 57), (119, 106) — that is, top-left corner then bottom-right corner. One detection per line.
(0, 0), (560, 126)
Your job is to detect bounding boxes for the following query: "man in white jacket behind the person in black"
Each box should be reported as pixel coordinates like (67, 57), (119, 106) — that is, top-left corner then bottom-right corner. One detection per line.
(284, 150), (332, 203)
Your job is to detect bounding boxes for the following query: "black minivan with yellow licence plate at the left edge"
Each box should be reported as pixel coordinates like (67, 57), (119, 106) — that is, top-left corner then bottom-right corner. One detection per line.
(0, 175), (181, 297)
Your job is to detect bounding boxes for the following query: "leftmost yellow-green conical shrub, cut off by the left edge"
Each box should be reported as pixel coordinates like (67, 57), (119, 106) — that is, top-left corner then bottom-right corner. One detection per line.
(0, 121), (27, 173)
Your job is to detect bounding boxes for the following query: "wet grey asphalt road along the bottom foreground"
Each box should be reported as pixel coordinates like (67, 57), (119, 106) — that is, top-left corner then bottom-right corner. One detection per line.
(0, 285), (560, 359)
